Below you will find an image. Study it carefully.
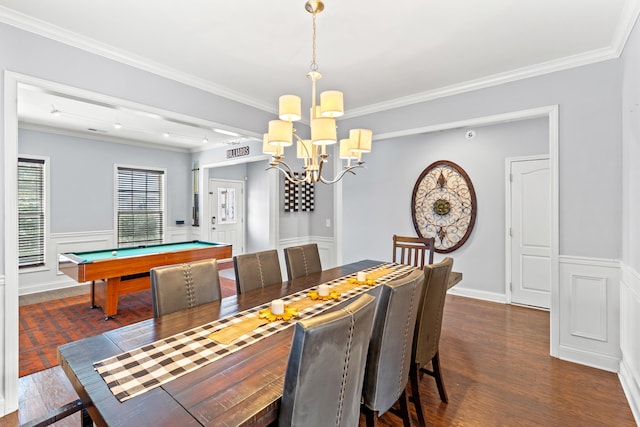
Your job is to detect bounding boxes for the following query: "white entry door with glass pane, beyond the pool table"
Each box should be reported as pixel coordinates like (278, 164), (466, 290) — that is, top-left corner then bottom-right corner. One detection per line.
(208, 179), (244, 255)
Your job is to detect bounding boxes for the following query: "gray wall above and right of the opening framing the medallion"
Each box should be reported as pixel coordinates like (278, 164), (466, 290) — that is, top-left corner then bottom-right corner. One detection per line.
(344, 60), (622, 259)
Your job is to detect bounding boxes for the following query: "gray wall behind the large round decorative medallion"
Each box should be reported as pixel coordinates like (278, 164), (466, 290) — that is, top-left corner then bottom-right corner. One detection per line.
(343, 119), (548, 293)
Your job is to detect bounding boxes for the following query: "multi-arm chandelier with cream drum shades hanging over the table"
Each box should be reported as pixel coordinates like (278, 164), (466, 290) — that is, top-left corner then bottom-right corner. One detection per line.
(262, 0), (373, 184)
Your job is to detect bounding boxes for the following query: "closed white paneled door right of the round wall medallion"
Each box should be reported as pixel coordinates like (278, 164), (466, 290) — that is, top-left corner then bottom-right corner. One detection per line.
(510, 157), (551, 309)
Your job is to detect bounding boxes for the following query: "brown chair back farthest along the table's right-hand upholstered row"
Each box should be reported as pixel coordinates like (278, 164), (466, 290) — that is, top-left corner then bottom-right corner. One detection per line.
(413, 257), (453, 368)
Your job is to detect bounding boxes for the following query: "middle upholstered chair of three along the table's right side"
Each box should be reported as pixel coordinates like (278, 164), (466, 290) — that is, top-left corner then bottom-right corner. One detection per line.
(362, 270), (424, 426)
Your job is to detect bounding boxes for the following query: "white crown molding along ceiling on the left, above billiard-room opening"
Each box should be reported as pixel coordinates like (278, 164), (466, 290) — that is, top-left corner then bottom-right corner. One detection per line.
(0, 6), (276, 113)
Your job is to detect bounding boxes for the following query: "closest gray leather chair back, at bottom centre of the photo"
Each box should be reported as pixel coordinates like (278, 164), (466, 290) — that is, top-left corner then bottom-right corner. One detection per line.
(278, 294), (376, 427)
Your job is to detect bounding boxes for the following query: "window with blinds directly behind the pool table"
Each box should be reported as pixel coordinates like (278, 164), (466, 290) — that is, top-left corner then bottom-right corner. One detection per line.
(117, 167), (164, 247)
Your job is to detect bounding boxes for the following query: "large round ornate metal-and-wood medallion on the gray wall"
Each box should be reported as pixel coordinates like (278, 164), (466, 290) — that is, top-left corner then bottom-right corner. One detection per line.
(411, 160), (476, 253)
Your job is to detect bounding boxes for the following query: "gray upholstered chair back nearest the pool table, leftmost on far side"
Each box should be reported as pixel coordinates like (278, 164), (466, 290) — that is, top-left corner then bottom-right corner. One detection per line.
(151, 259), (220, 317)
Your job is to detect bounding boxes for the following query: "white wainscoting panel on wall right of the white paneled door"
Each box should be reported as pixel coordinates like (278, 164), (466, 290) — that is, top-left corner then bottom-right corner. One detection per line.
(558, 256), (620, 372)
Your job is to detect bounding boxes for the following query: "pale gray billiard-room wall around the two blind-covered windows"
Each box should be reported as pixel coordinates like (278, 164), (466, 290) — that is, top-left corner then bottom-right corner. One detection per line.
(18, 129), (191, 233)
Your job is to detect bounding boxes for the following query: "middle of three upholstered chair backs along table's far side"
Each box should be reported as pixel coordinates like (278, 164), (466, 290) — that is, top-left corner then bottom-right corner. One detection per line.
(233, 249), (282, 294)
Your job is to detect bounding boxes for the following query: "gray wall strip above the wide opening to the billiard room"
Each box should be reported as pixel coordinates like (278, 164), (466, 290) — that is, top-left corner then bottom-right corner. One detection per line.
(0, 23), (273, 270)
